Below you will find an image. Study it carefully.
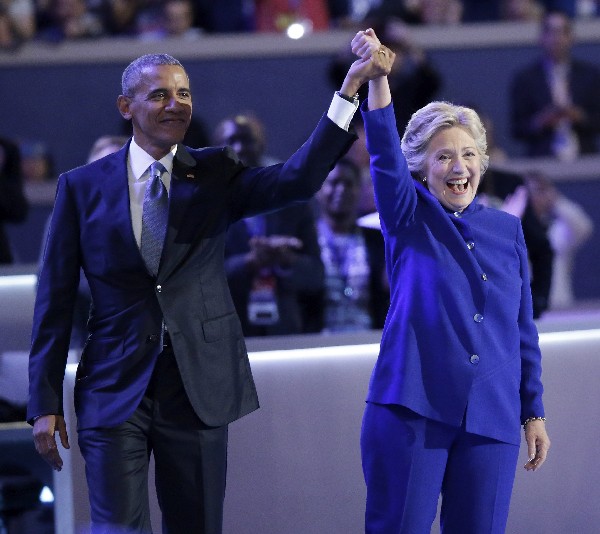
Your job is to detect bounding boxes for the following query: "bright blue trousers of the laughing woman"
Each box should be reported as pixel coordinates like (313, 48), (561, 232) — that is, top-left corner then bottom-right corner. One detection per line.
(361, 403), (519, 534)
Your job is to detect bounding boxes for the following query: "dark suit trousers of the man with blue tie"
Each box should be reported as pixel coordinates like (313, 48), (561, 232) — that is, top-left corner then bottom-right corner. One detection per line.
(78, 347), (228, 534)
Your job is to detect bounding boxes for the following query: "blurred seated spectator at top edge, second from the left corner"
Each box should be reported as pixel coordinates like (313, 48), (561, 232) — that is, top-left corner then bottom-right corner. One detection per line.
(37, 0), (104, 42)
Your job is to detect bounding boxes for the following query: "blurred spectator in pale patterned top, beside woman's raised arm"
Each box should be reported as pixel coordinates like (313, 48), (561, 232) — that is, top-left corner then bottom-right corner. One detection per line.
(317, 158), (389, 332)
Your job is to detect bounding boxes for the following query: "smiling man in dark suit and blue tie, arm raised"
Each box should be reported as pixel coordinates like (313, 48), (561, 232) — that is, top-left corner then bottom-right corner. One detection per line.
(27, 49), (390, 534)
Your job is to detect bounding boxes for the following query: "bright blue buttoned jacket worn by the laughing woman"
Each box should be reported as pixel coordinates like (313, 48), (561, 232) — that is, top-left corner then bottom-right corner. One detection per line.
(363, 105), (544, 444)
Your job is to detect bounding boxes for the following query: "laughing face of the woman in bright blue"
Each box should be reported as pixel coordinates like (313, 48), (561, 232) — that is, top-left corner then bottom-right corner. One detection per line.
(424, 126), (481, 211)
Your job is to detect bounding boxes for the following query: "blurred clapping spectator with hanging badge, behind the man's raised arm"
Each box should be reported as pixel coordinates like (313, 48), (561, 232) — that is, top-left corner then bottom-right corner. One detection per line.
(214, 114), (323, 336)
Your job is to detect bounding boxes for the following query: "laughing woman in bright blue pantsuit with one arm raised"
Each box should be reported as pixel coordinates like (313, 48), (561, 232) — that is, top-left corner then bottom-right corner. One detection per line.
(352, 30), (550, 534)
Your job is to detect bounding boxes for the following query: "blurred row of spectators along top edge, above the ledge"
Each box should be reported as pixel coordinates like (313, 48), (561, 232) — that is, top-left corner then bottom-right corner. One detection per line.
(0, 0), (600, 50)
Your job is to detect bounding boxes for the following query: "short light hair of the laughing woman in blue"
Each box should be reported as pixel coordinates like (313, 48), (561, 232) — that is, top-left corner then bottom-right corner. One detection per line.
(401, 101), (490, 178)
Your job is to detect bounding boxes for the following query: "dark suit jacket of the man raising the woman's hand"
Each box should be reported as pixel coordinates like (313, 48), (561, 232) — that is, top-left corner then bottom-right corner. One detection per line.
(27, 117), (354, 429)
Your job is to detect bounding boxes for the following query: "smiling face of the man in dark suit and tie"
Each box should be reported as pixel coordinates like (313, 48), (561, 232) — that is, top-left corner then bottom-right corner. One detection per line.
(117, 65), (192, 160)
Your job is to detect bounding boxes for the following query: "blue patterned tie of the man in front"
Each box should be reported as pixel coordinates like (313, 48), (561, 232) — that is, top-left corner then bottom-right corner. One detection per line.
(140, 161), (169, 276)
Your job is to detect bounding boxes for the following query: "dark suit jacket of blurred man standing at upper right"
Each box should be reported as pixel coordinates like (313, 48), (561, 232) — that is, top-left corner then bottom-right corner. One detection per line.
(510, 59), (600, 156)
